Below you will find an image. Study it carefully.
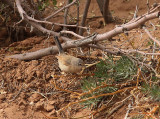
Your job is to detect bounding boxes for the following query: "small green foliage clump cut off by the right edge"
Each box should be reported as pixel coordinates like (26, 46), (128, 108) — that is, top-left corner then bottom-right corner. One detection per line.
(142, 83), (160, 101)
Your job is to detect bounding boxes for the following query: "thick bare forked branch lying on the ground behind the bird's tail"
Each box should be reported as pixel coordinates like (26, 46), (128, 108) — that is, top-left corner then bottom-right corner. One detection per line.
(6, 0), (160, 60)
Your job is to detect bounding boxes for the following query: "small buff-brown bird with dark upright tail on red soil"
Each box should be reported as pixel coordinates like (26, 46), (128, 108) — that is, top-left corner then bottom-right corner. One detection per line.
(54, 36), (85, 73)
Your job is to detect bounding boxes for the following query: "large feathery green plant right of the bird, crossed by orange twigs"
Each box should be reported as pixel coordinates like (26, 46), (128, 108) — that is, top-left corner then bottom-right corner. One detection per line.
(82, 56), (137, 106)
